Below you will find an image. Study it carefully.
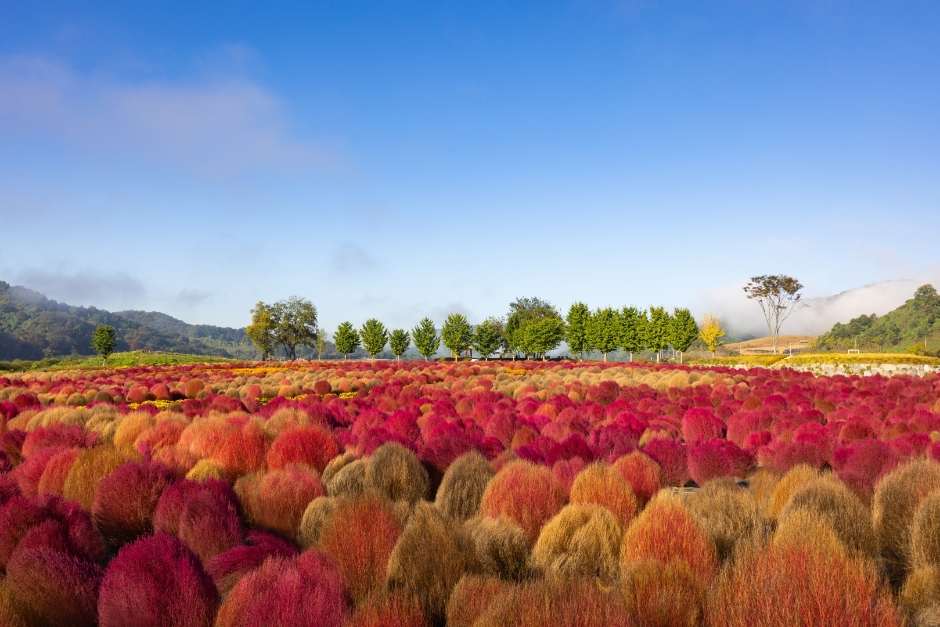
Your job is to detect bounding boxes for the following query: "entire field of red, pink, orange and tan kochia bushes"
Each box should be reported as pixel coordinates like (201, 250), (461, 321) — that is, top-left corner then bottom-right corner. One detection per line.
(0, 361), (940, 627)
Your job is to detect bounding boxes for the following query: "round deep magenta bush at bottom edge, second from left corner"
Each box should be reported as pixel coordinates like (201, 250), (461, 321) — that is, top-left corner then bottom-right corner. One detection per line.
(98, 533), (219, 627)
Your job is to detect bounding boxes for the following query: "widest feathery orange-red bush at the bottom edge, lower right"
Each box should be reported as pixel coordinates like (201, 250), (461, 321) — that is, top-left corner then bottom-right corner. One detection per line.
(706, 543), (904, 627)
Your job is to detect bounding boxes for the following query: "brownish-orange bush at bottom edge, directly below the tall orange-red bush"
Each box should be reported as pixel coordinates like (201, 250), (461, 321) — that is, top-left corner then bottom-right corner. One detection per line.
(620, 560), (705, 627)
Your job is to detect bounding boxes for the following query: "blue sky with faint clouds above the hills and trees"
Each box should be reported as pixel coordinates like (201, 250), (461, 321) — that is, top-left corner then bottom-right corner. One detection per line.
(0, 0), (940, 332)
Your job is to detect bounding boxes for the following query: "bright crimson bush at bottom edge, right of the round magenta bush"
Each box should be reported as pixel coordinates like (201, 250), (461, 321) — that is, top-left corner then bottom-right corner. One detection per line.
(214, 550), (348, 627)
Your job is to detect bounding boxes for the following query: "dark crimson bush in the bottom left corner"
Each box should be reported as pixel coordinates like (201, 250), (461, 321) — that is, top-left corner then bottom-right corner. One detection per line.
(4, 549), (102, 627)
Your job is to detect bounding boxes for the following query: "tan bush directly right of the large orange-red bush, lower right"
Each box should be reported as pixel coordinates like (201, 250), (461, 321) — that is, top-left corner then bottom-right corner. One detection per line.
(685, 478), (765, 561)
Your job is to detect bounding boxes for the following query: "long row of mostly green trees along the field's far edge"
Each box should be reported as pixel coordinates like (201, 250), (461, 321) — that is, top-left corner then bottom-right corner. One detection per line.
(245, 297), (720, 361)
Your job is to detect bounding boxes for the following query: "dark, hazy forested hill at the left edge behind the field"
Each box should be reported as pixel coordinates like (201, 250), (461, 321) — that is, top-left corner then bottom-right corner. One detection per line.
(0, 281), (258, 360)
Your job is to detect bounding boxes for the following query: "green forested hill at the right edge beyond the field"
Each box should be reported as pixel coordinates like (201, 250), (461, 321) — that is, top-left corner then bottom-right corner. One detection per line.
(818, 285), (940, 353)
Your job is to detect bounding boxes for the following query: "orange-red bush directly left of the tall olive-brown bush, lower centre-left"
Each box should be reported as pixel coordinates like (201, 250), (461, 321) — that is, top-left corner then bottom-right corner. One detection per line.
(319, 497), (401, 604)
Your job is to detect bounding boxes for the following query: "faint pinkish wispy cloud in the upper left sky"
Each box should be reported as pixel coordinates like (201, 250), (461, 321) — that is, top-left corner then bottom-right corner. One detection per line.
(0, 57), (343, 178)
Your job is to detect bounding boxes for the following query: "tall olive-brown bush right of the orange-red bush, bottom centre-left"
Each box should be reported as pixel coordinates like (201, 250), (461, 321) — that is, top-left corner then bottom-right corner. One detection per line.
(387, 502), (478, 622)
